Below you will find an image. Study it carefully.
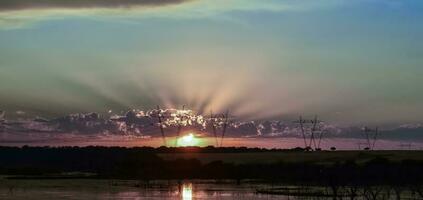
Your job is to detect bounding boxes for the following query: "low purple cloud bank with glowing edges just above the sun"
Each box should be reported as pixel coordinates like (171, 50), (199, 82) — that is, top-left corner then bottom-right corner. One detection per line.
(0, 109), (423, 143)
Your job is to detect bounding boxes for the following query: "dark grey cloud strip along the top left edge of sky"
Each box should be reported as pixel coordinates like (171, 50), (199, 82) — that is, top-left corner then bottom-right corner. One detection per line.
(0, 0), (189, 11)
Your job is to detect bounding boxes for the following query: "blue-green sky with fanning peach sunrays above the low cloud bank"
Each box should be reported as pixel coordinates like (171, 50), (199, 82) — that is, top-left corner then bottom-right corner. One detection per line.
(0, 0), (423, 147)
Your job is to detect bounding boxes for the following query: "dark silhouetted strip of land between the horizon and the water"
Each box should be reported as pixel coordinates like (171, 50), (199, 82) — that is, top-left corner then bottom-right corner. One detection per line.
(0, 147), (423, 187)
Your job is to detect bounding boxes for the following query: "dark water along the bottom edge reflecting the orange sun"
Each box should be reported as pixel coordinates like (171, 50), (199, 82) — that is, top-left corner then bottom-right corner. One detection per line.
(0, 177), (423, 200)
